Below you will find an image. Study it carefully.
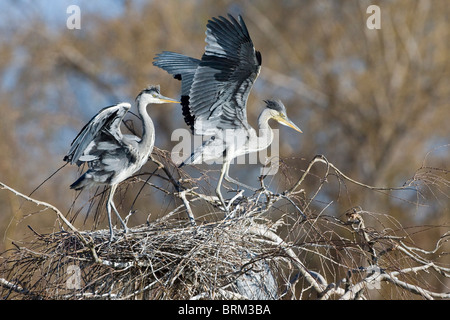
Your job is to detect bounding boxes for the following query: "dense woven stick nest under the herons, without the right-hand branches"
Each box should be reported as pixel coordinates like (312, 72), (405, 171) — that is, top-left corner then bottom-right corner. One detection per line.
(0, 214), (284, 299)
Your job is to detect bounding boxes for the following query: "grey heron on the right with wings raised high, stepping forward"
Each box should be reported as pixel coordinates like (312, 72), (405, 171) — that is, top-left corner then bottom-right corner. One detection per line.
(153, 15), (302, 210)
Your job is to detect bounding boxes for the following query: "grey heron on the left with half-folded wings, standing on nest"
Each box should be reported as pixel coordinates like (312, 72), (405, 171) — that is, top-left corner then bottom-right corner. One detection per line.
(64, 86), (179, 242)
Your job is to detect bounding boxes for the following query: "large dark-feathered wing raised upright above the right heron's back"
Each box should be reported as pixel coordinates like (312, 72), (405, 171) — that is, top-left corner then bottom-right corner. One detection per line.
(189, 15), (261, 135)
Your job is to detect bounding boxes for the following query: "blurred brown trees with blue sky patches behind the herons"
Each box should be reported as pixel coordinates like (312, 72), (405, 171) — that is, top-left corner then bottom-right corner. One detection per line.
(0, 0), (450, 296)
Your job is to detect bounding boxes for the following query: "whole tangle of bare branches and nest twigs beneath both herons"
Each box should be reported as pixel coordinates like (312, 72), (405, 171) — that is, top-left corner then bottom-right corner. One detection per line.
(0, 156), (450, 299)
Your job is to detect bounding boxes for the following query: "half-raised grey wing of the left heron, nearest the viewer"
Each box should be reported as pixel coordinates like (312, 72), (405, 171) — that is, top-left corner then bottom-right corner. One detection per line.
(64, 102), (131, 165)
